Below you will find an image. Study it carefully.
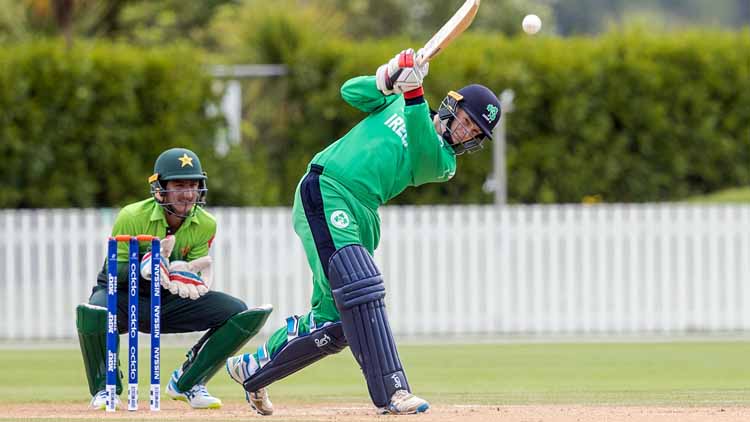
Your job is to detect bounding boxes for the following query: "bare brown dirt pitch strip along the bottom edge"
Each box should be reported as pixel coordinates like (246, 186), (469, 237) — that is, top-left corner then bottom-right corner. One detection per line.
(0, 401), (750, 422)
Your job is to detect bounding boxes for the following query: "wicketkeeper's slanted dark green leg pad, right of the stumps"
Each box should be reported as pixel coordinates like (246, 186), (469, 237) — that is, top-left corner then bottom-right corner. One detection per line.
(177, 305), (273, 391)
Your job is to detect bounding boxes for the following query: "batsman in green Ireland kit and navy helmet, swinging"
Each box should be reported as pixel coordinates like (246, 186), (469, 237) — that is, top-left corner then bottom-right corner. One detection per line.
(227, 49), (500, 415)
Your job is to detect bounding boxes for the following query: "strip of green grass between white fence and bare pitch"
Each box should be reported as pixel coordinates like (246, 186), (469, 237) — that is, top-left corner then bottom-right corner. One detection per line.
(0, 340), (750, 406)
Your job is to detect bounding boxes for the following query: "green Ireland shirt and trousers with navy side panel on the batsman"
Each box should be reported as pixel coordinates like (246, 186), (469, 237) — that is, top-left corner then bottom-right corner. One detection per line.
(254, 76), (456, 368)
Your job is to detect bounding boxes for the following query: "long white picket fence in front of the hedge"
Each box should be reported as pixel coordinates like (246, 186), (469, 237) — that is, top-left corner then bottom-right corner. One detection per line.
(0, 204), (750, 341)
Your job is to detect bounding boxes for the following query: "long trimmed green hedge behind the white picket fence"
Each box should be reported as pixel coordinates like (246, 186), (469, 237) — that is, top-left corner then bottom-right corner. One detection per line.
(0, 31), (750, 207)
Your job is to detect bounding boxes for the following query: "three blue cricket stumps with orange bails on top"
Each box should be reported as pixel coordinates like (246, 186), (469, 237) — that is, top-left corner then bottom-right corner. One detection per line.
(106, 235), (161, 412)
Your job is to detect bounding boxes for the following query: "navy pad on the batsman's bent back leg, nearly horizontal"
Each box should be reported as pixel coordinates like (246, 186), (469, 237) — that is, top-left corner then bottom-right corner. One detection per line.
(243, 317), (346, 393)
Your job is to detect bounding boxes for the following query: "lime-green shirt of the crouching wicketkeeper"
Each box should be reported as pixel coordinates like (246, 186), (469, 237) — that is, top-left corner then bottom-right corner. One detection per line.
(112, 198), (216, 262)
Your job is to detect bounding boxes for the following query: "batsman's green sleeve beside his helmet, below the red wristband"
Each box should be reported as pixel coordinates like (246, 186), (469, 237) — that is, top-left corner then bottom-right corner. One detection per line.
(404, 97), (456, 186)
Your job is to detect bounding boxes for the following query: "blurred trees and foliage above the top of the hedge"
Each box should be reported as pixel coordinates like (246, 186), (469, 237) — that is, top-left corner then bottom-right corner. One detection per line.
(5, 0), (750, 47)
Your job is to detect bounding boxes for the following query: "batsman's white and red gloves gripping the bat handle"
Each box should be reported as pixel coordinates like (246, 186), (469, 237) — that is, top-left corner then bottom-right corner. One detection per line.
(375, 48), (430, 95)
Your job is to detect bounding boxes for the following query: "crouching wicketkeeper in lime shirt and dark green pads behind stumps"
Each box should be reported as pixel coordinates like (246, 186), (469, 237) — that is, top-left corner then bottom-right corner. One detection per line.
(76, 148), (271, 409)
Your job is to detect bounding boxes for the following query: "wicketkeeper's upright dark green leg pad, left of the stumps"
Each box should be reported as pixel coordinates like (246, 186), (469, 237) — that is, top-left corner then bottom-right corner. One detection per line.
(76, 304), (122, 396)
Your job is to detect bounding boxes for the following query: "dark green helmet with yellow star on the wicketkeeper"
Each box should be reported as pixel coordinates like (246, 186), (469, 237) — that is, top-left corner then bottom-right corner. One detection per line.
(148, 148), (208, 218)
